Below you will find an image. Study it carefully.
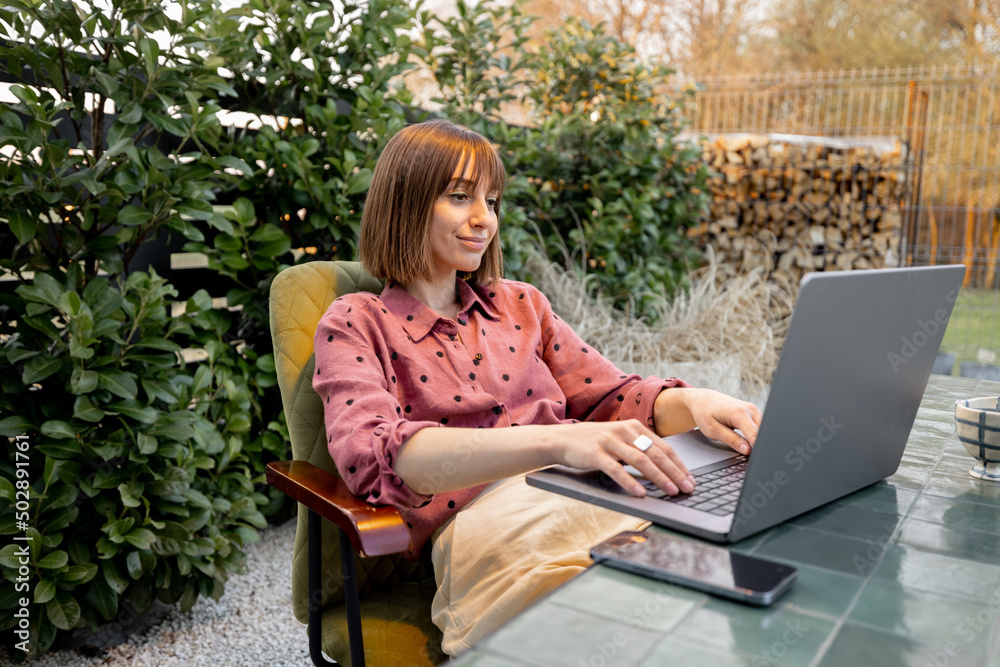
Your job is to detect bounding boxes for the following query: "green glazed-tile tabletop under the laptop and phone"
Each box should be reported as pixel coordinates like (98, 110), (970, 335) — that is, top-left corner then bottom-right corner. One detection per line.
(449, 376), (1000, 667)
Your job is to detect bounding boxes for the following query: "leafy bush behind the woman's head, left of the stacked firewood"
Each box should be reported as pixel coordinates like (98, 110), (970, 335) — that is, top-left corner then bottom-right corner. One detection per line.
(429, 2), (708, 318)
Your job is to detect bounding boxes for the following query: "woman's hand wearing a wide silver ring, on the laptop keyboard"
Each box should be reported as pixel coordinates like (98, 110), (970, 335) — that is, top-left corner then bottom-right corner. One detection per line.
(544, 419), (694, 496)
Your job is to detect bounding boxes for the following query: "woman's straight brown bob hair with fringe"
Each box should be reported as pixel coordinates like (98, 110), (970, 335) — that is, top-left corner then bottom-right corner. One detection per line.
(358, 120), (507, 285)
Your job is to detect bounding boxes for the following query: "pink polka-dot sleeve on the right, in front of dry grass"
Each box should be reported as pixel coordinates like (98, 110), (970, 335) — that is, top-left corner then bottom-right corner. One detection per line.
(530, 289), (691, 426)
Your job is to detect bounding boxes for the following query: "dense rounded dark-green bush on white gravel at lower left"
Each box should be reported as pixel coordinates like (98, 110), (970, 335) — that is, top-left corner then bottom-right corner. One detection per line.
(0, 265), (278, 657)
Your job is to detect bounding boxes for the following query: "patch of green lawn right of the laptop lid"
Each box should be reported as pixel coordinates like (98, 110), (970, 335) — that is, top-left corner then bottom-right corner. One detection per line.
(941, 288), (1000, 375)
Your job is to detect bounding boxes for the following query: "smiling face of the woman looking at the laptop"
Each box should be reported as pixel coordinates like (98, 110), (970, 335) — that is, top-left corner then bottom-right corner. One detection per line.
(428, 164), (497, 282)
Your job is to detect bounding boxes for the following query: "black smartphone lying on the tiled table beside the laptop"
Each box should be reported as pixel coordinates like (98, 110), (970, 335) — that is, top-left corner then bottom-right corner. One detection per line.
(590, 531), (798, 607)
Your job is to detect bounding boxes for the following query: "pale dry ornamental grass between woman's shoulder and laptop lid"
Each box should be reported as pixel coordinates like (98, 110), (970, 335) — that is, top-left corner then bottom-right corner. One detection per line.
(527, 245), (793, 401)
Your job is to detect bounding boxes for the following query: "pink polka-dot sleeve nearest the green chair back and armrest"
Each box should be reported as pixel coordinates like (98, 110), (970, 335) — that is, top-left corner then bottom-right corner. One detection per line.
(313, 299), (440, 509)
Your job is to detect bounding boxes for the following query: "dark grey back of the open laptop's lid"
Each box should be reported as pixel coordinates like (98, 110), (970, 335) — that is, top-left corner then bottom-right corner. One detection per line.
(728, 266), (965, 540)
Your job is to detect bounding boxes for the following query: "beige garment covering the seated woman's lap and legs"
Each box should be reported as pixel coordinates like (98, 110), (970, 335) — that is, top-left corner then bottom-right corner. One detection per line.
(431, 475), (649, 656)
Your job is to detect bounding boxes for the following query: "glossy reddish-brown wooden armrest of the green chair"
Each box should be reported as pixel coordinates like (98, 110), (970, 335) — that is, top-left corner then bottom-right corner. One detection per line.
(265, 461), (410, 557)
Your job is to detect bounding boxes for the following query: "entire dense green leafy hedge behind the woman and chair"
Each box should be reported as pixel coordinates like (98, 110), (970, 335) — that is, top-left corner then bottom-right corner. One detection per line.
(0, 0), (704, 660)
